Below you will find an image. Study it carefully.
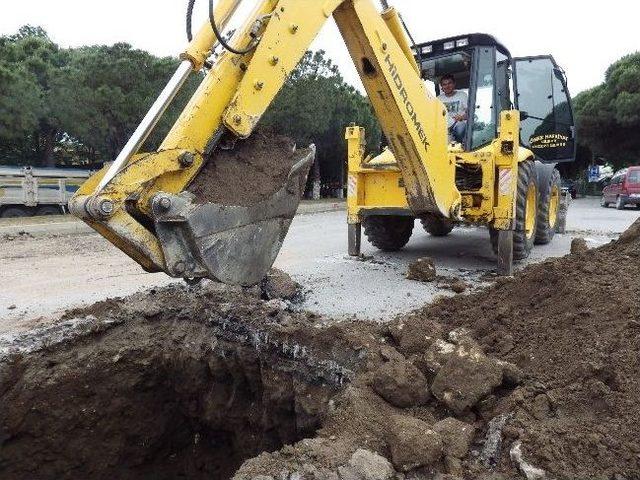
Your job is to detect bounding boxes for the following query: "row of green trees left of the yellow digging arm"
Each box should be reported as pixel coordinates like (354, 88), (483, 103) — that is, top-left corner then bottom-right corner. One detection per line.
(0, 26), (198, 166)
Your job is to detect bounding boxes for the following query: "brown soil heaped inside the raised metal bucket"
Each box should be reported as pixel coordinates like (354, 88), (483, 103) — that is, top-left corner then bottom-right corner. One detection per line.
(188, 130), (306, 206)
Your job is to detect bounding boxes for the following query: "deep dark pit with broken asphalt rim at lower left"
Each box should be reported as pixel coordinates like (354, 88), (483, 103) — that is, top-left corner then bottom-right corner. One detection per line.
(0, 284), (353, 479)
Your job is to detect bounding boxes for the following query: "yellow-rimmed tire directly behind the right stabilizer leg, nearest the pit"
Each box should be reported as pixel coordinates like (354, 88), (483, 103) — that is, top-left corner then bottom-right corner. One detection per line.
(489, 160), (538, 260)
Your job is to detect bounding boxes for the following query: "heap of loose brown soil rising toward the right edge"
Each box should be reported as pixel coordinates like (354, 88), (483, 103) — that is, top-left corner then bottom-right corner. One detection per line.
(403, 220), (640, 478)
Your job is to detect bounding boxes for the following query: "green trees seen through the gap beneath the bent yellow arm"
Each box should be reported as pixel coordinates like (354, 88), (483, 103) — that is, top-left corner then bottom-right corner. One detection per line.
(262, 50), (380, 184)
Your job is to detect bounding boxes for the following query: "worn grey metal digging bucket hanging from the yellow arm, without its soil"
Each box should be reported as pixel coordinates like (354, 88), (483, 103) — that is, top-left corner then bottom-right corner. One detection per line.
(147, 145), (315, 286)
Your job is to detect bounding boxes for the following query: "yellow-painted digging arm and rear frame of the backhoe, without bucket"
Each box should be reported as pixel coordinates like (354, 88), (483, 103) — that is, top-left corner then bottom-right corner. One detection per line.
(74, 0), (544, 278)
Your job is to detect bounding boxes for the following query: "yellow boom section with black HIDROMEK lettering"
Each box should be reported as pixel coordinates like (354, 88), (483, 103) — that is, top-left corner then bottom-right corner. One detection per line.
(334, 0), (460, 217)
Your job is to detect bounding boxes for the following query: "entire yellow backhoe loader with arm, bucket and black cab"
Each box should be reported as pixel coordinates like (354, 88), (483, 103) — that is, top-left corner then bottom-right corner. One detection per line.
(70, 0), (575, 285)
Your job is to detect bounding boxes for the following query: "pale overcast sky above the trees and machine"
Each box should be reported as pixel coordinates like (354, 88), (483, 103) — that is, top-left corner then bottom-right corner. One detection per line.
(0, 0), (640, 95)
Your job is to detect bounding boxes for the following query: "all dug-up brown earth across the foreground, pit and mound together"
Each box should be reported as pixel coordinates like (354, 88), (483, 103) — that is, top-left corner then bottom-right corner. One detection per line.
(0, 220), (640, 480)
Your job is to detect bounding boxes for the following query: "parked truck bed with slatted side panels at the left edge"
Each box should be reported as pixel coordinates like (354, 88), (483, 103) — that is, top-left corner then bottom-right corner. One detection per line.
(0, 167), (91, 217)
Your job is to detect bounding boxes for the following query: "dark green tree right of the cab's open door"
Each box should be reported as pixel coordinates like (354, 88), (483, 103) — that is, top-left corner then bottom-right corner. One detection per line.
(574, 52), (640, 168)
